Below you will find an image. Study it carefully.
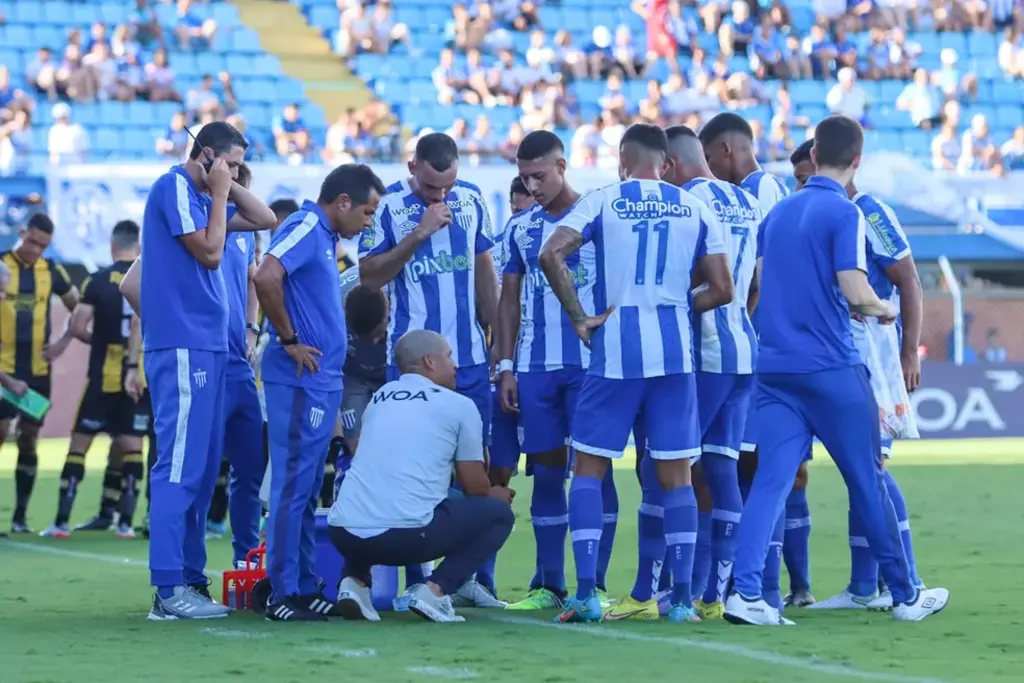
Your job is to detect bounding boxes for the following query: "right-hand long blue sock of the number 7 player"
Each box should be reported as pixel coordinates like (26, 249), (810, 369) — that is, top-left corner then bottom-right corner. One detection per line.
(695, 453), (743, 604)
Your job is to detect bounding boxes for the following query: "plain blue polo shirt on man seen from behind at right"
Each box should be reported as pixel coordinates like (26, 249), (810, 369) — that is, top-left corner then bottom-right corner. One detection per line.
(758, 175), (867, 373)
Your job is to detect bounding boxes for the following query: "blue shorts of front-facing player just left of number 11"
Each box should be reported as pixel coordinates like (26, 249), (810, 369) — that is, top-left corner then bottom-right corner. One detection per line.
(516, 368), (586, 454)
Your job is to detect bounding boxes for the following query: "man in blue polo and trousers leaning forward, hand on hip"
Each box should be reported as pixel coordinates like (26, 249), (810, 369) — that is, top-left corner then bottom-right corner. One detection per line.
(254, 164), (384, 622)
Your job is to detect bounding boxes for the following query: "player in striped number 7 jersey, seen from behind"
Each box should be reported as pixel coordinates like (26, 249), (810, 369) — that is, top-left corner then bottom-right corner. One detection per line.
(659, 126), (764, 618)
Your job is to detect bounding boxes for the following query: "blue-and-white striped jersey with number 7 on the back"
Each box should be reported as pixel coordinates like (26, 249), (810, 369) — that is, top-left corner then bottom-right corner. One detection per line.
(683, 178), (766, 375)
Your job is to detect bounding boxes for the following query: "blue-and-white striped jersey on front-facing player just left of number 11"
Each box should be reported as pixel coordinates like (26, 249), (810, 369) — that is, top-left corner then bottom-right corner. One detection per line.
(504, 205), (597, 373)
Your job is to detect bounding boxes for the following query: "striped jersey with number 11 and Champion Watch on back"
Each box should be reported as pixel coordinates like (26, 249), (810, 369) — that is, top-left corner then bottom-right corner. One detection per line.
(559, 180), (726, 379)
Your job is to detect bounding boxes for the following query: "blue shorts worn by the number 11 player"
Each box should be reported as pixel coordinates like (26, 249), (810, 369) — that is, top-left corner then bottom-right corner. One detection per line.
(572, 373), (700, 460)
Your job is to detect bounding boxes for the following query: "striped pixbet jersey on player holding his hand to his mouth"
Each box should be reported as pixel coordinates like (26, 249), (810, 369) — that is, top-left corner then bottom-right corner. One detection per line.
(359, 180), (494, 367)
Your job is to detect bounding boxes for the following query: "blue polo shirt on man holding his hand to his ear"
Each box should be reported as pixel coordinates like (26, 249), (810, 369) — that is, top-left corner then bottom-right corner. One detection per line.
(141, 166), (234, 351)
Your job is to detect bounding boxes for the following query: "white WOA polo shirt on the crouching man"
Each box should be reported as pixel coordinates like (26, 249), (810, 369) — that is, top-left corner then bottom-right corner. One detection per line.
(328, 374), (483, 539)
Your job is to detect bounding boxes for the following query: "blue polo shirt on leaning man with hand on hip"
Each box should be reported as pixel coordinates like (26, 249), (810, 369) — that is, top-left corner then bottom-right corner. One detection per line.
(261, 202), (348, 391)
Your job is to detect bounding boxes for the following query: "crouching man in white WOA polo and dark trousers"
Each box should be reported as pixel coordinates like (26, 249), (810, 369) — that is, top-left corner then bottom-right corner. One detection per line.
(328, 330), (515, 622)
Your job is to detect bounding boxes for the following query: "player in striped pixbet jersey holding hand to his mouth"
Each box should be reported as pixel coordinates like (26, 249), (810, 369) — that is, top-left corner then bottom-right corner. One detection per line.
(359, 133), (505, 607)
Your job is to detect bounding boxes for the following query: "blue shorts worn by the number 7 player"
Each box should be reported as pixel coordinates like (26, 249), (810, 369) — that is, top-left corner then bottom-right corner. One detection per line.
(697, 373), (754, 459)
